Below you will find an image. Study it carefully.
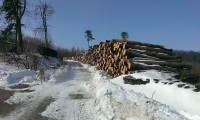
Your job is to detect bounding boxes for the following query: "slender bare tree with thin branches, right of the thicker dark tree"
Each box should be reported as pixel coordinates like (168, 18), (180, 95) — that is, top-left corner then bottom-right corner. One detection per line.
(35, 0), (54, 48)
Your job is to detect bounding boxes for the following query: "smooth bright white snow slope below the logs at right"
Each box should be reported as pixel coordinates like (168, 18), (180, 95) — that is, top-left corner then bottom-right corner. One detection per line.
(111, 70), (200, 120)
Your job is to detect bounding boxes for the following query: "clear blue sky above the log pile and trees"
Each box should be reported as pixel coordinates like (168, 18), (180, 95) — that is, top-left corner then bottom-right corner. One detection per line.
(0, 0), (200, 51)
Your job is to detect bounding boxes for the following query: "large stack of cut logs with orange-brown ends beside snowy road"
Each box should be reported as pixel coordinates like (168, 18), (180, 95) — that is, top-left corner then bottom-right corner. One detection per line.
(75, 39), (191, 77)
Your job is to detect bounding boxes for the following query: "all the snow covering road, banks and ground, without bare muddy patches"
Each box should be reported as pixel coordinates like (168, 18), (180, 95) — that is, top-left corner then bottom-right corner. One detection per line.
(0, 61), (200, 120)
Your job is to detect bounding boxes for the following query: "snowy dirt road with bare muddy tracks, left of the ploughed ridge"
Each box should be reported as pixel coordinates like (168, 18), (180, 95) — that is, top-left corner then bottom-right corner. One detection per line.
(0, 62), (95, 120)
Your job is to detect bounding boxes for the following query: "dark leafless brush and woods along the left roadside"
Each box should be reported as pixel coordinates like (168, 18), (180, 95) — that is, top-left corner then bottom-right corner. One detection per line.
(0, 34), (84, 70)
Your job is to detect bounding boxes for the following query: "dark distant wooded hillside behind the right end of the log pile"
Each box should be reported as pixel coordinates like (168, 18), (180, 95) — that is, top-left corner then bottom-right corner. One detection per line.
(174, 50), (200, 73)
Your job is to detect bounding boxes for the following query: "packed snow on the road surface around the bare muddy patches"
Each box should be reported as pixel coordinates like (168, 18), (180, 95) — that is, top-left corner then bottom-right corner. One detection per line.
(0, 61), (95, 120)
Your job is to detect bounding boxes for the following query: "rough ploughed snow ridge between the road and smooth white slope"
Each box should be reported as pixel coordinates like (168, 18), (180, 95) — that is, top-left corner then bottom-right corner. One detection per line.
(81, 65), (186, 120)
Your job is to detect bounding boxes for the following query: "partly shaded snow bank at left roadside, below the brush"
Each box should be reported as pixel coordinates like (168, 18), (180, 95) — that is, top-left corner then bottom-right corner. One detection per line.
(0, 57), (61, 86)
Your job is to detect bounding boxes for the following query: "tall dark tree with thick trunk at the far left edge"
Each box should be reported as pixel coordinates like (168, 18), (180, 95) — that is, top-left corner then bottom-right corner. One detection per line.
(0, 0), (26, 53)
